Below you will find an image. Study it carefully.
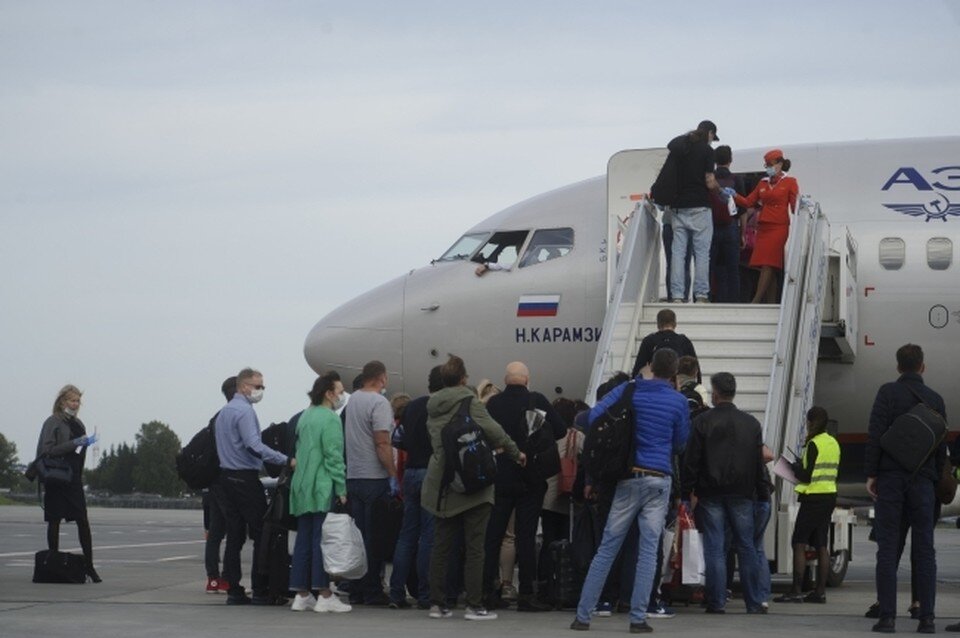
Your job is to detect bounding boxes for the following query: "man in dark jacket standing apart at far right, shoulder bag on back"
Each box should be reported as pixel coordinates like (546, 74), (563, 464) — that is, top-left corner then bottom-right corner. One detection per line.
(865, 344), (944, 634)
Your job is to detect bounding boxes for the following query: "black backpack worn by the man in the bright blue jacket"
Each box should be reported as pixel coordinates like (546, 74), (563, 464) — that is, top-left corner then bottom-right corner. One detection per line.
(580, 381), (637, 483)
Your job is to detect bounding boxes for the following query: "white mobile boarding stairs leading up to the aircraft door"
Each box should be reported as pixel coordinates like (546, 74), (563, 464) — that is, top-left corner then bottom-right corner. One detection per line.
(587, 198), (829, 476)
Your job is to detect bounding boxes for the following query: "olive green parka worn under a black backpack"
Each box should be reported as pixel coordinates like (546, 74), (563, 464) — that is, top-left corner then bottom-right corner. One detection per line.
(424, 385), (520, 518)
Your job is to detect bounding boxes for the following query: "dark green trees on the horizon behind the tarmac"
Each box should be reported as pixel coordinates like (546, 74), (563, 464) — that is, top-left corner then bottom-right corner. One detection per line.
(0, 421), (188, 496)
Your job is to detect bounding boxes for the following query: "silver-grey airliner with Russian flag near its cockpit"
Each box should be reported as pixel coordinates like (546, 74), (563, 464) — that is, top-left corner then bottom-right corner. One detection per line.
(304, 137), (960, 576)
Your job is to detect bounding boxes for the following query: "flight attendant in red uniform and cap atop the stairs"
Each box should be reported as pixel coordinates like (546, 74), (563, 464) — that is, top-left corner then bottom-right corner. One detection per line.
(730, 149), (800, 303)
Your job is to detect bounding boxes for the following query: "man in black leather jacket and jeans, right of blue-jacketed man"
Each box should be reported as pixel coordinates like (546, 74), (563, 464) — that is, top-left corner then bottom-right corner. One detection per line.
(680, 372), (769, 614)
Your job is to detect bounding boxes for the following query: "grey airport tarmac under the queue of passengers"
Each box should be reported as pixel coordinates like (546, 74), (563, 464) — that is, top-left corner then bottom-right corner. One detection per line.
(0, 506), (960, 638)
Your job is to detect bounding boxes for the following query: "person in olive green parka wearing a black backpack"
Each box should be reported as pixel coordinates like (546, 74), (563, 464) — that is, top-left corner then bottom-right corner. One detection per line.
(420, 355), (527, 620)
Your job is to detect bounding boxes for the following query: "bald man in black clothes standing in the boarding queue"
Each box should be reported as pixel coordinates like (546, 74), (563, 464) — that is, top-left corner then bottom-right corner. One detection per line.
(483, 361), (567, 611)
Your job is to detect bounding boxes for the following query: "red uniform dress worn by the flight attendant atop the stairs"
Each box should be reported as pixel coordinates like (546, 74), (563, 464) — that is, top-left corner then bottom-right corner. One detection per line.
(734, 173), (800, 270)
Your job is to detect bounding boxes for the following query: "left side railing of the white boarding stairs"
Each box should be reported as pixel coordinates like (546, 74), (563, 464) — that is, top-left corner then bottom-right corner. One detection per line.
(585, 198), (660, 405)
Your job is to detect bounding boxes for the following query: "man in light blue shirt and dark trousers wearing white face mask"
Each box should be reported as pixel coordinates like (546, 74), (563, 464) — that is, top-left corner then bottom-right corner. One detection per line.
(211, 368), (296, 605)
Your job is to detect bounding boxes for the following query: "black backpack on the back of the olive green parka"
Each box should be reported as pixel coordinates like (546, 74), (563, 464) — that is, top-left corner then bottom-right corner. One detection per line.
(437, 397), (497, 508)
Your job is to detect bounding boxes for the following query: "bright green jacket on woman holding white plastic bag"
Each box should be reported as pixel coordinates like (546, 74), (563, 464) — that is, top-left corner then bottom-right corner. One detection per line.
(290, 405), (347, 516)
